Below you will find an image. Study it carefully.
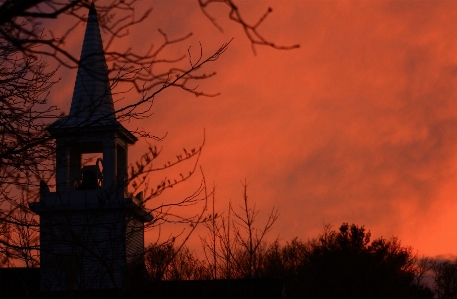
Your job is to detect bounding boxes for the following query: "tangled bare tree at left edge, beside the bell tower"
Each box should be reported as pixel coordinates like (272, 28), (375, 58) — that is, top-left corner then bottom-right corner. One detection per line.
(0, 47), (57, 266)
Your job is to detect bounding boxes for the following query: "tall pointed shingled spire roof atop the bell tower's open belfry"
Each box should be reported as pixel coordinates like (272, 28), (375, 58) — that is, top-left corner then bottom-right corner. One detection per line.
(48, 5), (136, 142)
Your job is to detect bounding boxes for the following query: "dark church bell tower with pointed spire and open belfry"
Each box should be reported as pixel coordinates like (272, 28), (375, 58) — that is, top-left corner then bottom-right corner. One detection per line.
(29, 6), (152, 291)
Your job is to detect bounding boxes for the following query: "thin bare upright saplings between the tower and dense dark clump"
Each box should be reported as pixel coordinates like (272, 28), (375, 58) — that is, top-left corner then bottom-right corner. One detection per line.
(201, 181), (279, 279)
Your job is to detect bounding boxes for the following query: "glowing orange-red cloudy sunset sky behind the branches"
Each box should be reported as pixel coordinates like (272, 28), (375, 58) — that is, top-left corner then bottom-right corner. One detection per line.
(50, 0), (457, 256)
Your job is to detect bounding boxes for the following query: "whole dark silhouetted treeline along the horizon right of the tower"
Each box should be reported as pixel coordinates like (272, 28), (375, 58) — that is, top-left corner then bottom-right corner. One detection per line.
(141, 223), (457, 299)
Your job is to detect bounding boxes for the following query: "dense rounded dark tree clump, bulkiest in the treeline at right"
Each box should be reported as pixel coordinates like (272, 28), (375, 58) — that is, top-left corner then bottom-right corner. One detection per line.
(278, 223), (433, 298)
